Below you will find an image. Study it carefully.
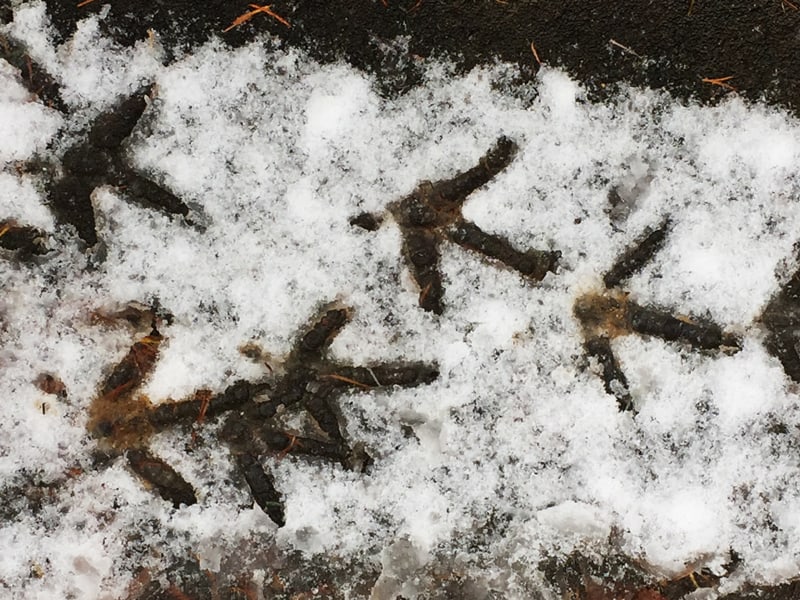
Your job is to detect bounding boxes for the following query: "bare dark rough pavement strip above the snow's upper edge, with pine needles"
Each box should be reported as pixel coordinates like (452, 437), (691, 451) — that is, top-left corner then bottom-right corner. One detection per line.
(28, 0), (800, 113)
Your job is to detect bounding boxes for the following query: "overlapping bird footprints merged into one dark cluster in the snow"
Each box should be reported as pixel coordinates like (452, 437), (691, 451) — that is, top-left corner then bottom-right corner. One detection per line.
(88, 307), (439, 526)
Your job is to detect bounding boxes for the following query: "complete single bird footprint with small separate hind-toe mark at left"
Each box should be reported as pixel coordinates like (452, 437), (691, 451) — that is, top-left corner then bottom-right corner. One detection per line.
(350, 137), (561, 315)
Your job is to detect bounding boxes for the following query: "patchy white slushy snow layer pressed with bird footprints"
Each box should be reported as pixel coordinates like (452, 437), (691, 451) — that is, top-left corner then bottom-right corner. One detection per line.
(0, 2), (800, 598)
